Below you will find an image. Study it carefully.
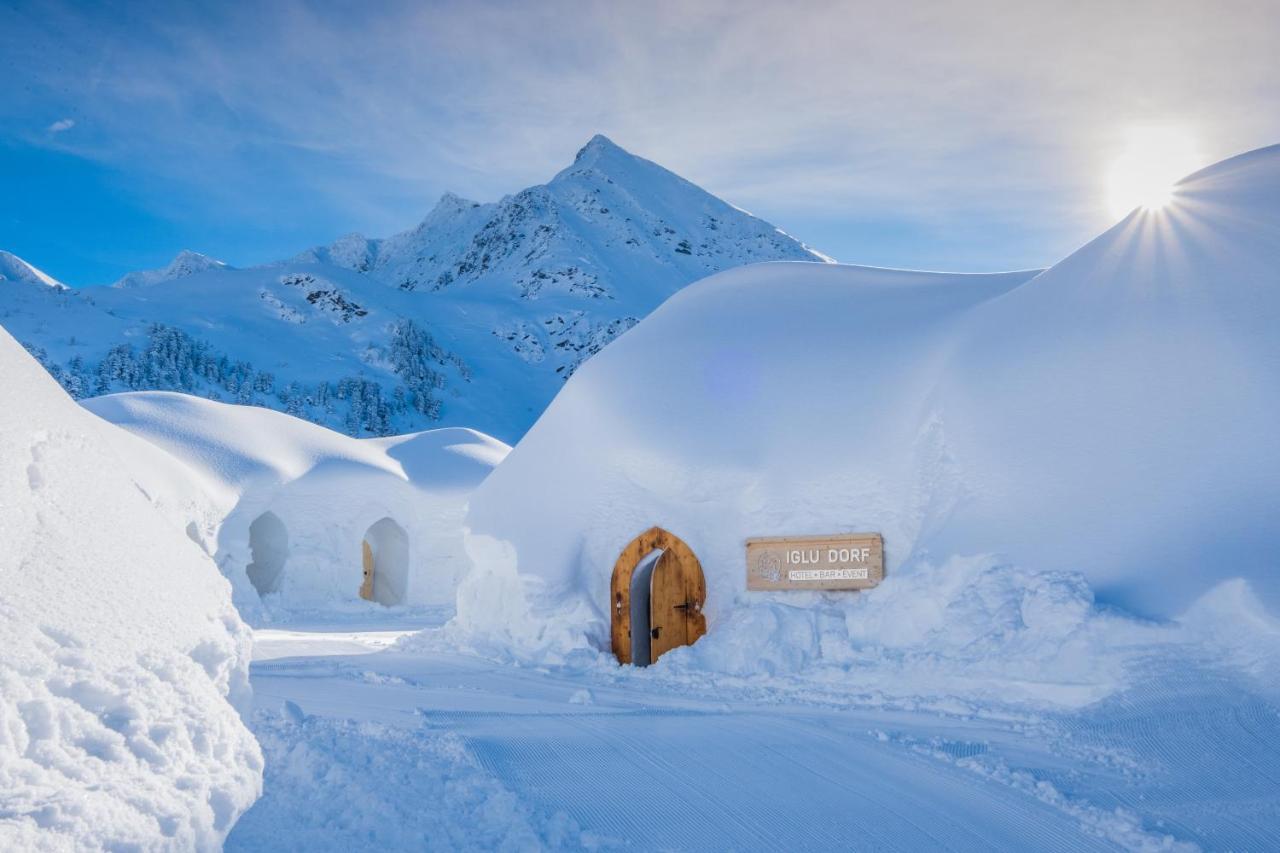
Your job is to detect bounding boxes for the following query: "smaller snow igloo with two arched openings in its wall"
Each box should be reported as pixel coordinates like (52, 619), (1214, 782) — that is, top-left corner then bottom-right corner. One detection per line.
(84, 392), (508, 620)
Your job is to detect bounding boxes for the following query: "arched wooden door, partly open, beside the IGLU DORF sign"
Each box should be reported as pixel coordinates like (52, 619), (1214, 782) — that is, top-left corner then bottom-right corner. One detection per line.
(609, 528), (707, 665)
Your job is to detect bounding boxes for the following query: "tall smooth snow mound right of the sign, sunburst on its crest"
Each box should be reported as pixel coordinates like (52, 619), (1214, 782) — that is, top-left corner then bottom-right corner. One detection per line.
(920, 146), (1280, 616)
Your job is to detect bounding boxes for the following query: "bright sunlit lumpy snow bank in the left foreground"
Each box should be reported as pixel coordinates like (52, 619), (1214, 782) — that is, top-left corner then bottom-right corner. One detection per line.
(0, 324), (262, 849)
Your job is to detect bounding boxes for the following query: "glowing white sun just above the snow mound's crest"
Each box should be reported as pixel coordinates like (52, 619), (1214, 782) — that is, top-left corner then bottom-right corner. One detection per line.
(1107, 124), (1203, 219)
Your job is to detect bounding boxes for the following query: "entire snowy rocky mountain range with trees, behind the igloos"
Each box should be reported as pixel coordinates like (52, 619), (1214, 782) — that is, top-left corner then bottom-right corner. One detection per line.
(0, 136), (829, 442)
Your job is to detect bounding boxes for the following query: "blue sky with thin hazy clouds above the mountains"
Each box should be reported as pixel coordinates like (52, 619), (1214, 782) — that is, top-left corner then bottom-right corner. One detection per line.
(0, 0), (1280, 284)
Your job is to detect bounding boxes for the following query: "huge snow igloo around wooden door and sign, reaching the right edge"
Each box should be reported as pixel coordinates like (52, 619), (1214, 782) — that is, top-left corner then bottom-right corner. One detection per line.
(458, 142), (1280, 671)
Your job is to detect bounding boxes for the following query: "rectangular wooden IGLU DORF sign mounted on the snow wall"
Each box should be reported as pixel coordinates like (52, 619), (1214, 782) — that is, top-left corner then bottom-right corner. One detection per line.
(746, 533), (884, 589)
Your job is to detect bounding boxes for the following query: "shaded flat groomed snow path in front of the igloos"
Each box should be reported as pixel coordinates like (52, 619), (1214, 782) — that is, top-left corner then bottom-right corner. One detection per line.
(228, 624), (1280, 850)
